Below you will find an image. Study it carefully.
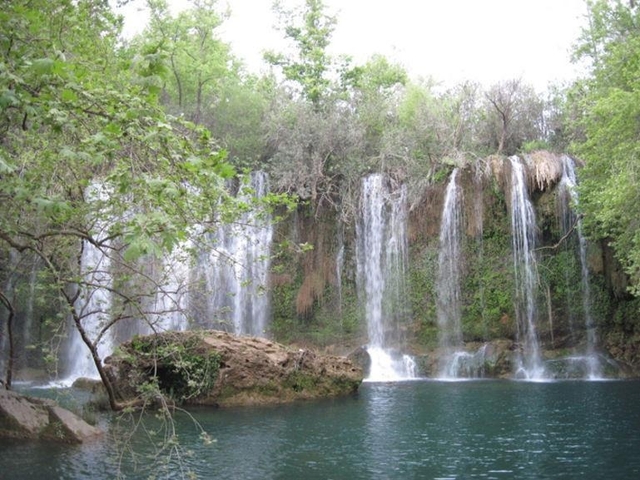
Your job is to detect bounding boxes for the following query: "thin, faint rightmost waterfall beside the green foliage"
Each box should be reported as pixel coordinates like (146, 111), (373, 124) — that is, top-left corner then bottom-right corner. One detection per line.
(559, 155), (602, 380)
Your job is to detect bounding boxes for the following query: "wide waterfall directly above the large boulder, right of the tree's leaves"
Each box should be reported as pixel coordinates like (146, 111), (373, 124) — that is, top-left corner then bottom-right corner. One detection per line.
(204, 172), (273, 337)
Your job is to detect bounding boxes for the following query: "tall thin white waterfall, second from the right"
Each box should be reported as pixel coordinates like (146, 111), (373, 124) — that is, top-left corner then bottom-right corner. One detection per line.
(509, 156), (545, 380)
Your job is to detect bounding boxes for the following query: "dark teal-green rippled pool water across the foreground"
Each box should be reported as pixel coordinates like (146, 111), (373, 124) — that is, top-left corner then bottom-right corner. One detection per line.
(0, 381), (640, 479)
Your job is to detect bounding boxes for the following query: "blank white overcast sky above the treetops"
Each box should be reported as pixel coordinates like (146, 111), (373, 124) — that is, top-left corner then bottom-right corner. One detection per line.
(120, 0), (586, 90)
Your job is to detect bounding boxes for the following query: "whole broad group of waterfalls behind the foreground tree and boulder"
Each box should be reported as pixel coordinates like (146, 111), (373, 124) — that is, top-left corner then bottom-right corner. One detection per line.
(61, 172), (273, 385)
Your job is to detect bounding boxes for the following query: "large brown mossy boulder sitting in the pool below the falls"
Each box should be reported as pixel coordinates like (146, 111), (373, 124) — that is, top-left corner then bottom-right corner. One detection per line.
(107, 331), (363, 406)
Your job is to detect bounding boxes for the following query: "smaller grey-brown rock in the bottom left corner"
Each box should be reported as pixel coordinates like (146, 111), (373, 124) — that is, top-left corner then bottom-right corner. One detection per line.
(0, 390), (102, 443)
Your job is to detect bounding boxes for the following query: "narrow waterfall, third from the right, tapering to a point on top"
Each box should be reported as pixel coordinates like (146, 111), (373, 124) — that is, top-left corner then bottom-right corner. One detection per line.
(436, 168), (464, 378)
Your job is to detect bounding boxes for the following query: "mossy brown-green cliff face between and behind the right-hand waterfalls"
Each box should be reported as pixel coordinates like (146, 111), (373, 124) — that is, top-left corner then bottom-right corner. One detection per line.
(271, 152), (640, 376)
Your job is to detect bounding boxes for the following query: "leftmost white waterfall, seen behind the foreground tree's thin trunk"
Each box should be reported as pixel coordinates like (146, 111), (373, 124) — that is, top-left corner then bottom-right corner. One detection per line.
(61, 183), (114, 385)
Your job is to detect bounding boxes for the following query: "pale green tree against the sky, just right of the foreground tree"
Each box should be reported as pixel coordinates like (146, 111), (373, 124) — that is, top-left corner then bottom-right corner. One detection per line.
(136, 0), (273, 168)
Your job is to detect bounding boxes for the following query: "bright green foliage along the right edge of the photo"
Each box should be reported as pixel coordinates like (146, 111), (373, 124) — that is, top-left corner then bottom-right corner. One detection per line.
(567, 0), (640, 295)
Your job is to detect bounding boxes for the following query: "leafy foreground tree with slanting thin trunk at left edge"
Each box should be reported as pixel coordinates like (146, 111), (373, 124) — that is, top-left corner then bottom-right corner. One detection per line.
(0, 0), (234, 409)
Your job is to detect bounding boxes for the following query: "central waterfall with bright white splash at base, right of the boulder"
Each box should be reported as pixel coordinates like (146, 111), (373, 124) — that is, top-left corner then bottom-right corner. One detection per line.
(356, 174), (415, 381)
